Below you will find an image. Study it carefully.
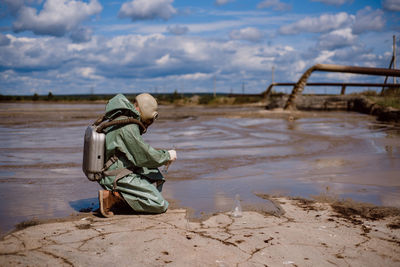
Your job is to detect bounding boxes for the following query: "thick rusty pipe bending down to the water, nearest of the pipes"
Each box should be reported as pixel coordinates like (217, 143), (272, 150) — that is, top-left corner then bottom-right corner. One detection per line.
(284, 64), (400, 109)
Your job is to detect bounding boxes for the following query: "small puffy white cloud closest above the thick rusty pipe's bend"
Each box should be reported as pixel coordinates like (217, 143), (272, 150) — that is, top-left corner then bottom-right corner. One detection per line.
(318, 28), (357, 50)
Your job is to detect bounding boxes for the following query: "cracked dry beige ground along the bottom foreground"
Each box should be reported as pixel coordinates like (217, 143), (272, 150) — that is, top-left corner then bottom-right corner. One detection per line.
(0, 198), (400, 266)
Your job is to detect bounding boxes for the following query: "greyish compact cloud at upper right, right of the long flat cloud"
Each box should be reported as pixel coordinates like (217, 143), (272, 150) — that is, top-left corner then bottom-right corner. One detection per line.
(353, 6), (386, 34)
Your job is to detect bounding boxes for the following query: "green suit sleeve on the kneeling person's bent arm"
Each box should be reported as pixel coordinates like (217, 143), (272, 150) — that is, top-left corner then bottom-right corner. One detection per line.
(117, 124), (170, 168)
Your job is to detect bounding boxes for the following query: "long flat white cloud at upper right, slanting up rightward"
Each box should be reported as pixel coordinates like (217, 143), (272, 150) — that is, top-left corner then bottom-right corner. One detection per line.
(279, 12), (354, 34)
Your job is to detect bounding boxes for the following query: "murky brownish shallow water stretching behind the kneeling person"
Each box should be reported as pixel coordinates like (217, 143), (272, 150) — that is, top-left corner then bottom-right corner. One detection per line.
(0, 103), (400, 237)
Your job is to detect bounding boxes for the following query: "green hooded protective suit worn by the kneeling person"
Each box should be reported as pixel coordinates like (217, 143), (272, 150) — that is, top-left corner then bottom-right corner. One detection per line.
(99, 94), (170, 213)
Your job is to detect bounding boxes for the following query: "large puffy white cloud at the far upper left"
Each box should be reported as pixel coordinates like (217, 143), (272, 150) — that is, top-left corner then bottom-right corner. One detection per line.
(13, 0), (102, 36)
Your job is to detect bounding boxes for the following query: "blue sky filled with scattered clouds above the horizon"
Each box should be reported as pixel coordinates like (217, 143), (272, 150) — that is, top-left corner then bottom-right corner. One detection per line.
(0, 0), (400, 95)
